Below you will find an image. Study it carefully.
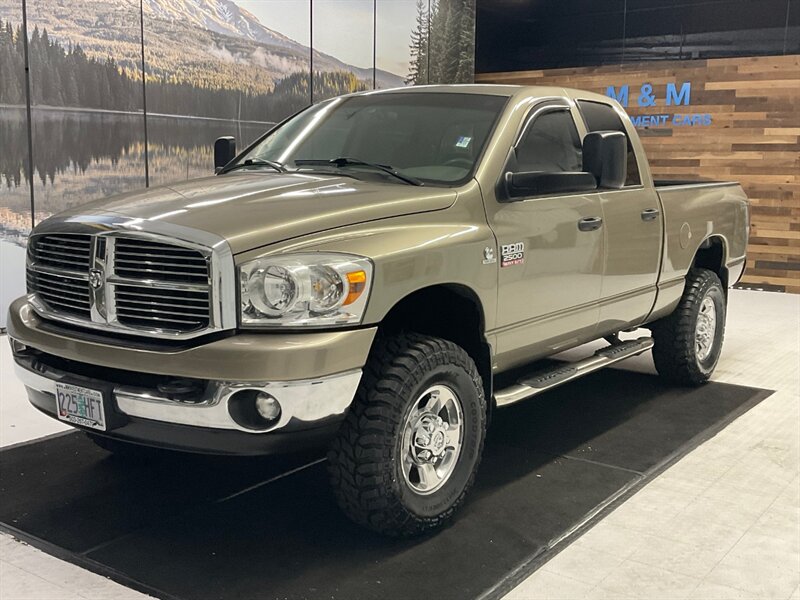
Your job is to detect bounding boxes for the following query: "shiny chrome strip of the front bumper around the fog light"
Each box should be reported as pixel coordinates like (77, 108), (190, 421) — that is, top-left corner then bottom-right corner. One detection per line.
(15, 360), (361, 434)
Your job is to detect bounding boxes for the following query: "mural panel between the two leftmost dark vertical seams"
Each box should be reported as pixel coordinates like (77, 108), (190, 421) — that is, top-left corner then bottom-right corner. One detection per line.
(28, 0), (145, 222)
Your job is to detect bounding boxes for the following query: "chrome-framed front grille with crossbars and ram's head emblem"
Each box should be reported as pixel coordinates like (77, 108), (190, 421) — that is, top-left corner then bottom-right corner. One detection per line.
(27, 231), (220, 338)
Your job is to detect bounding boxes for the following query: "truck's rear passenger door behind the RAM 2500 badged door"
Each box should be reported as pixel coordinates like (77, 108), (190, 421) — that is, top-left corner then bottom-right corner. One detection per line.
(577, 99), (663, 335)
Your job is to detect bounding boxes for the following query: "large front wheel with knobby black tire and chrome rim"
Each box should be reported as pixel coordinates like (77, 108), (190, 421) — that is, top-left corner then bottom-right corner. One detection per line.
(328, 334), (486, 536)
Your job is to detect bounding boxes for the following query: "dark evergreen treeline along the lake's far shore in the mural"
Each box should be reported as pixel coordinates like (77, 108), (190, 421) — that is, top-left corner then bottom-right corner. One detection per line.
(0, 21), (368, 121)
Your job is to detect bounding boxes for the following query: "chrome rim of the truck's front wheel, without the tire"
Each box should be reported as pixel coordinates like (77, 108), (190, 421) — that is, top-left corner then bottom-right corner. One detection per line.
(402, 385), (464, 496)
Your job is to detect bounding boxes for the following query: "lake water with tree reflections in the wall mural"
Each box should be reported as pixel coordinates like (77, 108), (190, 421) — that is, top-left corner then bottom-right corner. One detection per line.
(0, 107), (269, 239)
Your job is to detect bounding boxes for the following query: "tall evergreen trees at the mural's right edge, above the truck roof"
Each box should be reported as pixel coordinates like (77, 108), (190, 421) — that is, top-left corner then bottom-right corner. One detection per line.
(406, 0), (475, 85)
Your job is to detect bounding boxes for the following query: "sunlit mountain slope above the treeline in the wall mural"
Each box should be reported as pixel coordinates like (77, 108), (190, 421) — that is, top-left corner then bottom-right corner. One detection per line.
(0, 0), (403, 101)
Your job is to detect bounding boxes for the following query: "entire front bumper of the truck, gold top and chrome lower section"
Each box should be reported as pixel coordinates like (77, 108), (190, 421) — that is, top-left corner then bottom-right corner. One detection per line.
(8, 301), (375, 454)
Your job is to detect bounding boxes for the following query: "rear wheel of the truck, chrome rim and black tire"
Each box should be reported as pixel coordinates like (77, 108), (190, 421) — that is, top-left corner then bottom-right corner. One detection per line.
(652, 269), (726, 385)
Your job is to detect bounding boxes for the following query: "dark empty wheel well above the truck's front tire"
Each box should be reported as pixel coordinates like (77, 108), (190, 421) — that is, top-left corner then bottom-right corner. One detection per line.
(380, 284), (493, 416)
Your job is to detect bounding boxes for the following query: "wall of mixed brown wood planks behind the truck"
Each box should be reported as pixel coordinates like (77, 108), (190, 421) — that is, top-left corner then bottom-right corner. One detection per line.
(476, 55), (800, 293)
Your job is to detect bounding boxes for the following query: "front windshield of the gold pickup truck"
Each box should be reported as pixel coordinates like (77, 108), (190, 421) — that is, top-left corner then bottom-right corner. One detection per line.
(237, 92), (507, 185)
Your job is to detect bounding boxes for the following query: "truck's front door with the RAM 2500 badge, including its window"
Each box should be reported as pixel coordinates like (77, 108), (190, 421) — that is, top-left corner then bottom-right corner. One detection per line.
(486, 100), (604, 369)
